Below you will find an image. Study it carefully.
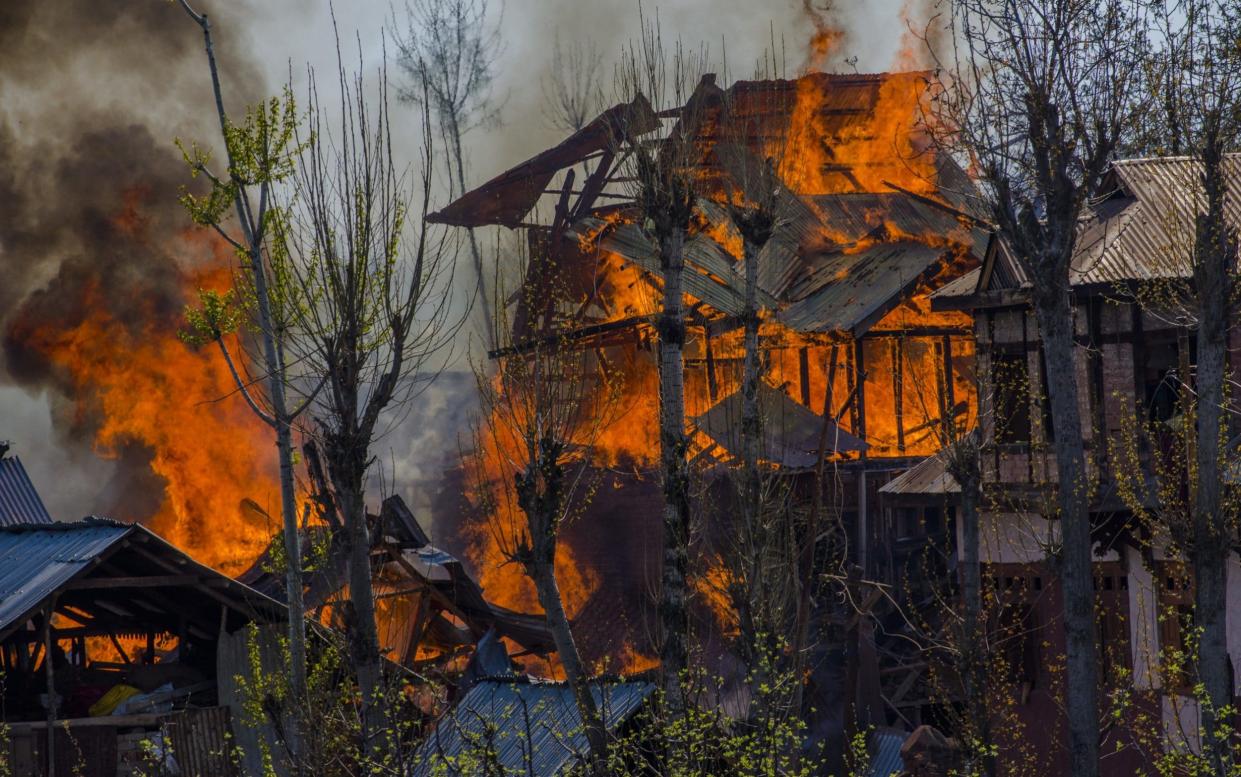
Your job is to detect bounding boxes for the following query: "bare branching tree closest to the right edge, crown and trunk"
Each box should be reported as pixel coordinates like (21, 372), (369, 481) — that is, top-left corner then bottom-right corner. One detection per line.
(1148, 0), (1241, 775)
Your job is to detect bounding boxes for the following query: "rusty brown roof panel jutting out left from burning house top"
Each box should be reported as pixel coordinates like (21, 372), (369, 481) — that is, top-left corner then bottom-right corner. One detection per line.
(427, 94), (659, 227)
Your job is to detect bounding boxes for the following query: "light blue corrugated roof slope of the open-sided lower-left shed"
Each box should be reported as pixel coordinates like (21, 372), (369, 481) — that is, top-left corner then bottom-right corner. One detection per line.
(0, 519), (133, 632)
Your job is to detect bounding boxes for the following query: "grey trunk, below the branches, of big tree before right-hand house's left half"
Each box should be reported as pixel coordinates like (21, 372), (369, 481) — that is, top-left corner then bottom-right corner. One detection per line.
(1034, 289), (1100, 777)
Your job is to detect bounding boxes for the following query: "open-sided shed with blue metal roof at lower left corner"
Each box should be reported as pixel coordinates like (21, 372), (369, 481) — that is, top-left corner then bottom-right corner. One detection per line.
(0, 518), (285, 777)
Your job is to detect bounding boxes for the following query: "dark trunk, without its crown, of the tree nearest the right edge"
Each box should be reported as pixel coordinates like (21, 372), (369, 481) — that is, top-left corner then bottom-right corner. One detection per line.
(1193, 133), (1232, 776)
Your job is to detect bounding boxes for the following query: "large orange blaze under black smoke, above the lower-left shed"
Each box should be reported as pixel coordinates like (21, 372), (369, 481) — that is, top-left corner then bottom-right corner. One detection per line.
(14, 233), (279, 575)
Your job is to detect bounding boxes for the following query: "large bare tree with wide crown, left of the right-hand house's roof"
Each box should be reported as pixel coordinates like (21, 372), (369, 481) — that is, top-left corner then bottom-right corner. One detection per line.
(936, 0), (1145, 777)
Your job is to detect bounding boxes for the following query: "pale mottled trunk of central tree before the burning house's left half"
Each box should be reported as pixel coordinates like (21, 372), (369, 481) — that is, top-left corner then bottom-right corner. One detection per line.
(658, 226), (690, 705)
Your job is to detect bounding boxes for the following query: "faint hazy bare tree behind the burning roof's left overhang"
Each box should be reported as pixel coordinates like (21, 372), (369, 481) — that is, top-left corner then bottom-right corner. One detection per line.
(393, 0), (504, 348)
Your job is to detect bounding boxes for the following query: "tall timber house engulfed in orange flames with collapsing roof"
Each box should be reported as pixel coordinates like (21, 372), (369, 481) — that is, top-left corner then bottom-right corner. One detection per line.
(432, 73), (988, 749)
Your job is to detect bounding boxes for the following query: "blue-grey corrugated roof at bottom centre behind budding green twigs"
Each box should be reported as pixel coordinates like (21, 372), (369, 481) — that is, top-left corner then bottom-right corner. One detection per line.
(413, 678), (655, 777)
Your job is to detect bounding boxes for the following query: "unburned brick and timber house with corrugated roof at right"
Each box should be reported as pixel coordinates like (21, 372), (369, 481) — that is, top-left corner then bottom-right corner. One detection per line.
(928, 155), (1241, 775)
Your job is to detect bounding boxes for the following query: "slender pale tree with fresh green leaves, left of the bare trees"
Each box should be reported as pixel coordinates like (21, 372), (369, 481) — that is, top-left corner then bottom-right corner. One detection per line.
(180, 0), (310, 751)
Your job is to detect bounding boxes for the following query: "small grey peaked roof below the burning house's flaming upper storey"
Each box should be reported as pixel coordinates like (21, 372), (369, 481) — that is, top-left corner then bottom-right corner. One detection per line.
(694, 382), (866, 461)
